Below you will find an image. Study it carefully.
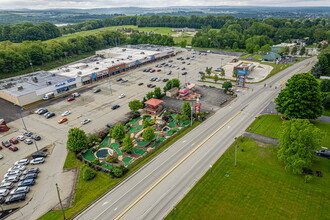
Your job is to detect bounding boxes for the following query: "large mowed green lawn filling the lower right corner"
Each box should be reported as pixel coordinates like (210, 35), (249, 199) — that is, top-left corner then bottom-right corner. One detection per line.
(166, 138), (330, 220)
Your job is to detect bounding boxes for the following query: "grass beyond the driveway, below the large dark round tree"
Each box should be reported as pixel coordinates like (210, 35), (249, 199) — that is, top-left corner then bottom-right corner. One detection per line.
(246, 114), (330, 147)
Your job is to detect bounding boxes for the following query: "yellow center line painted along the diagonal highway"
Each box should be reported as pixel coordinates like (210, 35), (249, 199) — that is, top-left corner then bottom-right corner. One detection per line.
(114, 110), (242, 219)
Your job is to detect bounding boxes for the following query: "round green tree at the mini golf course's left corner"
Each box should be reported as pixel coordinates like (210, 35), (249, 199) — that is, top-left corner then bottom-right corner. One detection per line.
(66, 128), (88, 152)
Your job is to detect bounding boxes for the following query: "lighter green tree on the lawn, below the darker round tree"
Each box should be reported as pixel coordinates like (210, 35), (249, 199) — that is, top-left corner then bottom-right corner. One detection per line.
(277, 119), (320, 174)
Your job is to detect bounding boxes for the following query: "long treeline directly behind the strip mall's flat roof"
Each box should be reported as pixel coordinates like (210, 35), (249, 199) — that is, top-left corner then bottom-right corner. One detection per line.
(0, 31), (174, 75)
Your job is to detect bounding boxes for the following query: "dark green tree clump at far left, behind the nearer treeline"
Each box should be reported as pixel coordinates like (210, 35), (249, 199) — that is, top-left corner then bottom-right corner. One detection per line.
(0, 22), (62, 43)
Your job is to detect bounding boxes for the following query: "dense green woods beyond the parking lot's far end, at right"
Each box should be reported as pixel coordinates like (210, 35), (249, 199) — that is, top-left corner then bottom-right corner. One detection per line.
(192, 19), (330, 53)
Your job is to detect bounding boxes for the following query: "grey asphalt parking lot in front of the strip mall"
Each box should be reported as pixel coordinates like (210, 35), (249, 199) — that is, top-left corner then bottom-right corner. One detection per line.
(0, 48), (237, 219)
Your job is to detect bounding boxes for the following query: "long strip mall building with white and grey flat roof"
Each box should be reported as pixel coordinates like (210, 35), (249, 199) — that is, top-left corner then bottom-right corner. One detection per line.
(0, 45), (176, 106)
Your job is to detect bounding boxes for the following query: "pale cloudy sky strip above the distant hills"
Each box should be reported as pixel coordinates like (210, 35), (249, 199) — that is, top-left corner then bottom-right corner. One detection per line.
(0, 0), (330, 9)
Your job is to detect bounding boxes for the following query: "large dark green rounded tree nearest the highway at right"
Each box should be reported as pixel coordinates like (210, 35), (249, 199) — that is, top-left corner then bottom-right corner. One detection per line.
(275, 73), (323, 119)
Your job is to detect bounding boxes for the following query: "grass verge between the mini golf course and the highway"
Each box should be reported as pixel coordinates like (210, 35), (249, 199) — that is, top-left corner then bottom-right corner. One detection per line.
(39, 122), (200, 220)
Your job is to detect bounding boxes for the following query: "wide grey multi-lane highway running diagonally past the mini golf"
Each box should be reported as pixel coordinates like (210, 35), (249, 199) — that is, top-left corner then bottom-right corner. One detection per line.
(75, 57), (316, 220)
